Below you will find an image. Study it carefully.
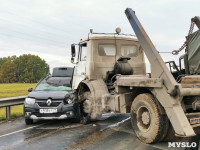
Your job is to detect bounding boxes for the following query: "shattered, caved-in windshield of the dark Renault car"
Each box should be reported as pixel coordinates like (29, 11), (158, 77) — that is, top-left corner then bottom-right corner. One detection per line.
(35, 79), (71, 91)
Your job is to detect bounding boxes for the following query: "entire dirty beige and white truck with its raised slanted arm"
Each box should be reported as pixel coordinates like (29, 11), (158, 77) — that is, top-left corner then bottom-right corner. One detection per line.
(72, 8), (200, 143)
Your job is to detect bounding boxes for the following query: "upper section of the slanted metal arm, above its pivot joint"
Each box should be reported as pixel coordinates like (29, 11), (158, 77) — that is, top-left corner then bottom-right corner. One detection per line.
(125, 8), (177, 96)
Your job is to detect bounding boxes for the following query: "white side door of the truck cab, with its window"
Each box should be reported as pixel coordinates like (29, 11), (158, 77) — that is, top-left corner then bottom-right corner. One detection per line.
(72, 43), (87, 89)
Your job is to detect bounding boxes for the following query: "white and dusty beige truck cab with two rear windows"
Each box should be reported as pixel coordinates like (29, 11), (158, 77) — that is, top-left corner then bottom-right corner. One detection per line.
(72, 34), (146, 89)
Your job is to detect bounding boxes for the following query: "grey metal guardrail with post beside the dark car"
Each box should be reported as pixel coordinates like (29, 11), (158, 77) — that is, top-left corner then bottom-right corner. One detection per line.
(0, 96), (27, 120)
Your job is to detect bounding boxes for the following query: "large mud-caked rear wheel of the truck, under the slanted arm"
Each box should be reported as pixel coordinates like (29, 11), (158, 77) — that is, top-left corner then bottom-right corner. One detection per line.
(131, 93), (168, 143)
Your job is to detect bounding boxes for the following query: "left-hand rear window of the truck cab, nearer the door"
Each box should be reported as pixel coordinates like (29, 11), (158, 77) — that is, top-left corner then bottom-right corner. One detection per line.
(98, 44), (116, 56)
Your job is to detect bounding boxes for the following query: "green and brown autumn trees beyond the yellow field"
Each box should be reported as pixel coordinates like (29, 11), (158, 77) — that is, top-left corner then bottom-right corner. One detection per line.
(0, 54), (49, 83)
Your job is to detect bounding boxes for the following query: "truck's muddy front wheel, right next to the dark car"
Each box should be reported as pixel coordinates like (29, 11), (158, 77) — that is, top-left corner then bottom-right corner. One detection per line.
(80, 91), (91, 124)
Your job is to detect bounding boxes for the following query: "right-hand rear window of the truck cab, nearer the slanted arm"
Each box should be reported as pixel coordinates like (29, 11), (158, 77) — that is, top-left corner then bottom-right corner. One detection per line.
(121, 45), (138, 57)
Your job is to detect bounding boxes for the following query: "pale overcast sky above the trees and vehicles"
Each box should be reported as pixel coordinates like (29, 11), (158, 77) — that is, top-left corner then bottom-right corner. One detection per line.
(0, 0), (200, 70)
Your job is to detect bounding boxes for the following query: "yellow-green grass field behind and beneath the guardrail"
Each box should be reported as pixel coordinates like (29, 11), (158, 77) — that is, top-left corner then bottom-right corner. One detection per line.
(0, 83), (36, 121)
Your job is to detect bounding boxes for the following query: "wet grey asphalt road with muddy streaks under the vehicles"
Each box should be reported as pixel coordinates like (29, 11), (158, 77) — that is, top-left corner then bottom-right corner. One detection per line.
(0, 114), (184, 150)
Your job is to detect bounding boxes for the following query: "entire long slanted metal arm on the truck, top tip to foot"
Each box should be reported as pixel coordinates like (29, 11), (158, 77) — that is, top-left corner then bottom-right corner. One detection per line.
(125, 8), (195, 136)
